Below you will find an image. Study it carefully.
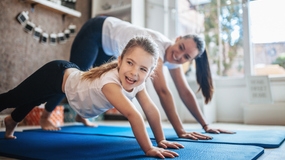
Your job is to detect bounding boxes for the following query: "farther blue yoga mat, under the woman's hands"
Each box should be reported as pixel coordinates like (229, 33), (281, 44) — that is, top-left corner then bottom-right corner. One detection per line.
(23, 125), (285, 148)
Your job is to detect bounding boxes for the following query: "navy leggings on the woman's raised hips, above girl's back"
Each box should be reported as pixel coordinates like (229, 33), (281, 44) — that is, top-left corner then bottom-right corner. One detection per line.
(70, 16), (112, 71)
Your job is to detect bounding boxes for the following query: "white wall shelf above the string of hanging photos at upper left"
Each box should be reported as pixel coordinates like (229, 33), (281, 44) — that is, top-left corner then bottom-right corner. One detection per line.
(26, 0), (81, 17)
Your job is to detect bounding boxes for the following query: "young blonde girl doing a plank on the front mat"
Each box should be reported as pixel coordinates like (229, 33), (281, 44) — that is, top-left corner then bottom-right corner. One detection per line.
(0, 37), (183, 158)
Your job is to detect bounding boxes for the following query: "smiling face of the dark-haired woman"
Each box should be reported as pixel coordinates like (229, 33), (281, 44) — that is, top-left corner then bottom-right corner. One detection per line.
(165, 37), (199, 64)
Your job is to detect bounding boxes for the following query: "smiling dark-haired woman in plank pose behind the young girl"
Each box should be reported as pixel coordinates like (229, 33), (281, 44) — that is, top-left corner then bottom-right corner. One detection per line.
(65, 16), (234, 139)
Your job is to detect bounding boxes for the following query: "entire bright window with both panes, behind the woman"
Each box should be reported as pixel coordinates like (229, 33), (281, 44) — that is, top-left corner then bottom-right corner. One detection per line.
(178, 0), (285, 77)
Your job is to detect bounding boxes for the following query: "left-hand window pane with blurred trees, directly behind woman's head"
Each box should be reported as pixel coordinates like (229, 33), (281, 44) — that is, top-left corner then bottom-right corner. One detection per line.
(178, 0), (244, 77)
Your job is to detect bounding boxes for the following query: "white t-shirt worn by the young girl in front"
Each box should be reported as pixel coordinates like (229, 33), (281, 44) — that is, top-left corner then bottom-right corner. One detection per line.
(65, 68), (145, 118)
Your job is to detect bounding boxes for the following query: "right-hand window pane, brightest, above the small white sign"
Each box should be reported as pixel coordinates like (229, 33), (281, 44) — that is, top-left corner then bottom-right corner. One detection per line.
(249, 0), (285, 75)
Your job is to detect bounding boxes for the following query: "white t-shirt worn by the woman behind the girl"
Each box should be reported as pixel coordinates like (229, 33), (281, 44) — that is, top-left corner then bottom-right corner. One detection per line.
(102, 17), (180, 69)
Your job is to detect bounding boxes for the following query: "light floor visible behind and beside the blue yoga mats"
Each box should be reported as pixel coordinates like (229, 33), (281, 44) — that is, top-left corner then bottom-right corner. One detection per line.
(0, 121), (285, 160)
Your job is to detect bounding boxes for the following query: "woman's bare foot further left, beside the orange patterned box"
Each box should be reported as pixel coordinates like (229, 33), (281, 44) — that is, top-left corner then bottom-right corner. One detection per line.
(40, 109), (60, 131)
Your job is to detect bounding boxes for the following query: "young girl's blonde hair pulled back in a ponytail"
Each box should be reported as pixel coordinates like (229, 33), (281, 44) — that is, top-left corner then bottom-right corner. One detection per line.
(82, 36), (159, 80)
